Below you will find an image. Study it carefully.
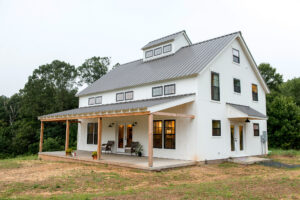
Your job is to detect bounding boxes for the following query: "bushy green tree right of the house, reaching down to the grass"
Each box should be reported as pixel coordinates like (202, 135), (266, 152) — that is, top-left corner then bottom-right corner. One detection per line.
(267, 95), (300, 149)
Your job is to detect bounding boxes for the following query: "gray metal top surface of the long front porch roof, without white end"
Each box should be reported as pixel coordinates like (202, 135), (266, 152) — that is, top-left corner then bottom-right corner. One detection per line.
(39, 93), (195, 118)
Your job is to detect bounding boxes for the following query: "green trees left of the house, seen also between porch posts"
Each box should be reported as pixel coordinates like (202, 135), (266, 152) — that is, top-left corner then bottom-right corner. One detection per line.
(0, 57), (110, 158)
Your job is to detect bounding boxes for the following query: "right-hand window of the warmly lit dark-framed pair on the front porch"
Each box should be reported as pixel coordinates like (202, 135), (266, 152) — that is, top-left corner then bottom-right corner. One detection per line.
(164, 120), (175, 149)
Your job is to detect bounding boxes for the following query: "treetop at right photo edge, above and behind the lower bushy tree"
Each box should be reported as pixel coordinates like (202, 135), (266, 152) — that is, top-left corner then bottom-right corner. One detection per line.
(280, 78), (300, 106)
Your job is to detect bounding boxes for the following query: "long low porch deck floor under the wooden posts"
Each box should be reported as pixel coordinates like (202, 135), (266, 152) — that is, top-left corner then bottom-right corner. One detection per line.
(39, 150), (197, 171)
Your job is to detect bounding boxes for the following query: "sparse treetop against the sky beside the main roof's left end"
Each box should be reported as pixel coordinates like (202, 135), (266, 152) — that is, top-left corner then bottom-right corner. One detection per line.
(78, 56), (110, 85)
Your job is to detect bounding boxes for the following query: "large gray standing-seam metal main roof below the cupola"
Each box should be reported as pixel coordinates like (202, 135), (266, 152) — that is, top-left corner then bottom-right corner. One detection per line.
(77, 32), (240, 96)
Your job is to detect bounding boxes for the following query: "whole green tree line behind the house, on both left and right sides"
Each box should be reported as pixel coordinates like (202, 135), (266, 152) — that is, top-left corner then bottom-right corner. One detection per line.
(0, 61), (300, 158)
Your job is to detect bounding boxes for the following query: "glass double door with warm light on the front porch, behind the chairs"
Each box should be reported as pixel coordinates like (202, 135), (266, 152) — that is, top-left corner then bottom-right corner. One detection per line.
(117, 124), (132, 152)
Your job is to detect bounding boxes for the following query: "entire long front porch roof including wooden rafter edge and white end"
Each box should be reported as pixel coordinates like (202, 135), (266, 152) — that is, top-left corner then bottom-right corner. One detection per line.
(38, 93), (195, 121)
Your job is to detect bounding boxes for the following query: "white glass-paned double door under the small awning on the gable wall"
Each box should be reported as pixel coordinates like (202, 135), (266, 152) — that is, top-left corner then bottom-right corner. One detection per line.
(230, 124), (244, 155)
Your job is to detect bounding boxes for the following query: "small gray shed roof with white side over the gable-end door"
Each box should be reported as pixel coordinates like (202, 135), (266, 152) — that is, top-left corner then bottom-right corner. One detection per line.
(226, 103), (268, 120)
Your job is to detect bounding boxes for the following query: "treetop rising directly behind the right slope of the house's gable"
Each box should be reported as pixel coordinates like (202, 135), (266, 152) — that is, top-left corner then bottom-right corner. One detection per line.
(258, 63), (283, 91)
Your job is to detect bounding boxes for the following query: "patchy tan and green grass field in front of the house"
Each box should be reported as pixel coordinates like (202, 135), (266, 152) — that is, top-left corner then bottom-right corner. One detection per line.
(0, 151), (300, 199)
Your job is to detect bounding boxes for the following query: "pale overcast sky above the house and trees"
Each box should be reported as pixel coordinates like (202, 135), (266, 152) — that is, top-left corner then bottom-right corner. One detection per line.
(0, 0), (300, 96)
